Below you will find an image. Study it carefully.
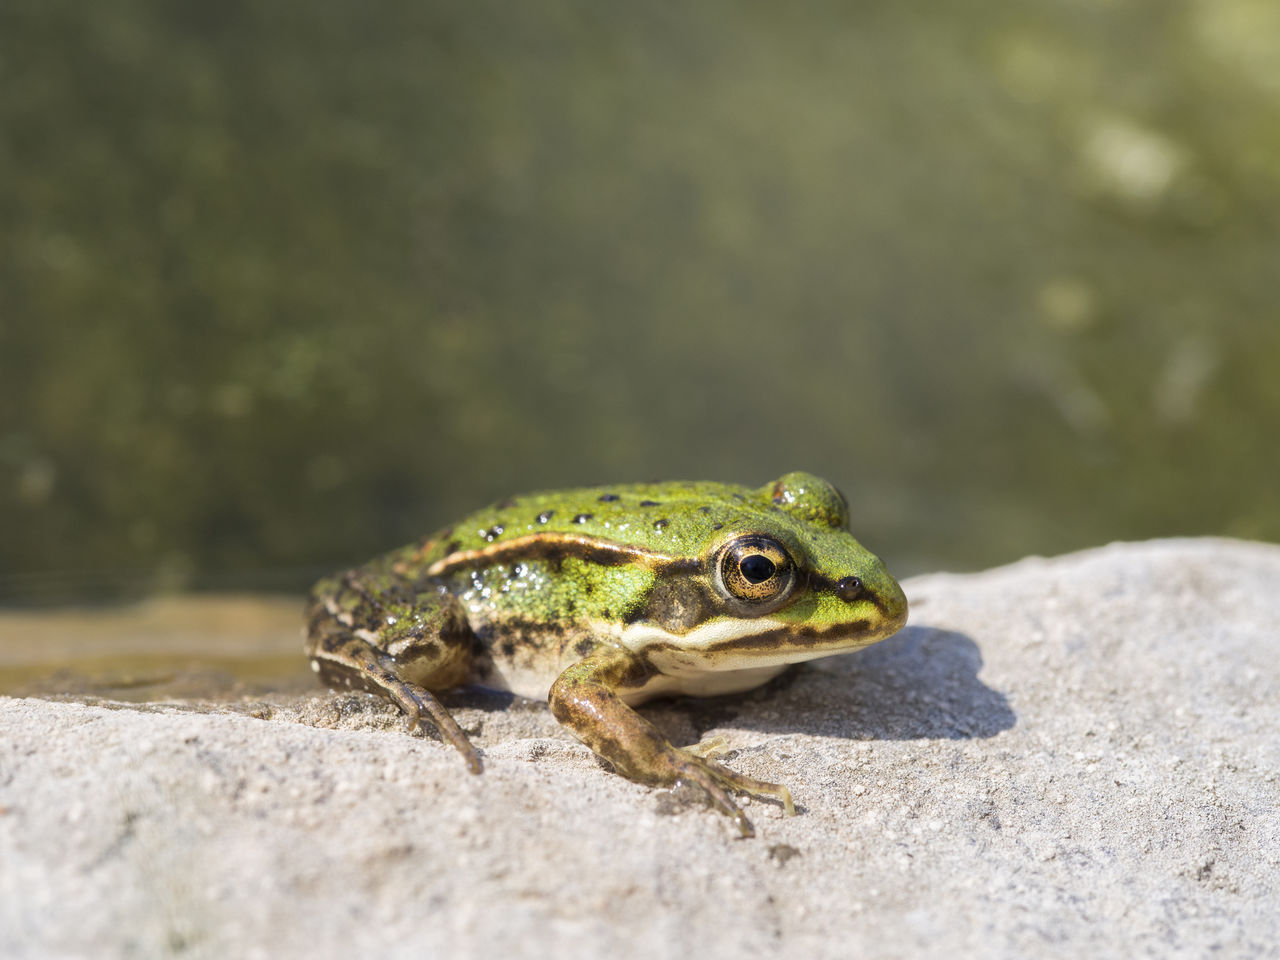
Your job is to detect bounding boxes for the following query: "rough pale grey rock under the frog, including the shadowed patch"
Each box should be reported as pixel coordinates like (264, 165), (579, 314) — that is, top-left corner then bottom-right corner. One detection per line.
(0, 540), (1280, 960)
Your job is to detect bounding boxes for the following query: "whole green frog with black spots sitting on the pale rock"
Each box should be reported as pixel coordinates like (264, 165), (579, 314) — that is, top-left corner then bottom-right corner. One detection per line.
(305, 472), (908, 837)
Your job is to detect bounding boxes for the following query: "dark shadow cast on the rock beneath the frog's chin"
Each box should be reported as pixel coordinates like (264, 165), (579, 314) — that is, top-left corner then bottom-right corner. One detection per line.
(686, 626), (1016, 740)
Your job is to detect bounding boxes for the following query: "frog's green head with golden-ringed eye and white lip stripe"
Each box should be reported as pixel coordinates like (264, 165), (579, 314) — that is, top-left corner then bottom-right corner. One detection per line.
(629, 472), (906, 669)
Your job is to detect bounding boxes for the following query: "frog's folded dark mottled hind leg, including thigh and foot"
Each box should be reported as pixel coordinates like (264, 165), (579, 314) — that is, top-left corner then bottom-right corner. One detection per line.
(306, 571), (483, 773)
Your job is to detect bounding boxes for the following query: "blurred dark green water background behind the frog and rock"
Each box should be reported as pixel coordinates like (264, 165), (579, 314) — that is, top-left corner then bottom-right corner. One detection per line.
(0, 0), (1280, 604)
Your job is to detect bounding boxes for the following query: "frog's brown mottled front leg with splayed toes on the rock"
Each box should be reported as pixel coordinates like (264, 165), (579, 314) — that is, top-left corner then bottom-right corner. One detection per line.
(548, 650), (795, 837)
